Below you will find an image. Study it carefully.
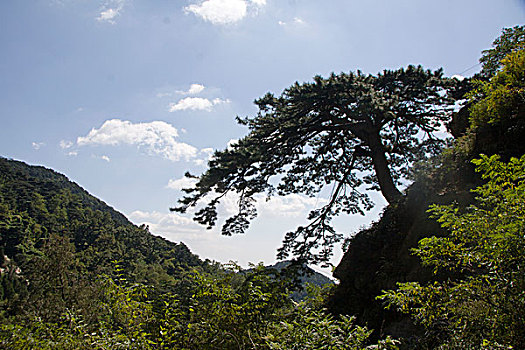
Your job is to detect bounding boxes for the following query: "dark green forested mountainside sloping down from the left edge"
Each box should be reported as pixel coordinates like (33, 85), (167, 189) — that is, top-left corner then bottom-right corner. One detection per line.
(0, 158), (204, 280)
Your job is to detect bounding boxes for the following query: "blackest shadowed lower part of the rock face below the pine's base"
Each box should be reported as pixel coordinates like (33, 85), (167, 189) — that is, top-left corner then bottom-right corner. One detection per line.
(329, 183), (471, 337)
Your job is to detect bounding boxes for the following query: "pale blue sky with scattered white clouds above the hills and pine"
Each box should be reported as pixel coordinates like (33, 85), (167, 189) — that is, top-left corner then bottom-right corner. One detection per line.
(0, 0), (525, 274)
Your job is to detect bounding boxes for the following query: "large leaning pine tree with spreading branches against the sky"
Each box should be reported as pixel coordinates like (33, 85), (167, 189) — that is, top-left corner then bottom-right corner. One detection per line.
(172, 66), (458, 263)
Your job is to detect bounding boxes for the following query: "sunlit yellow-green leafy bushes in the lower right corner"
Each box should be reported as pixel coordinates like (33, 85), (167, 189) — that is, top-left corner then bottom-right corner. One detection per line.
(381, 155), (525, 349)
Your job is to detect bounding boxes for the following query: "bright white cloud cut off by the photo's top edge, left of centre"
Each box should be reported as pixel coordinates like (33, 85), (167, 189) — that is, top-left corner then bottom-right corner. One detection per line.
(184, 0), (266, 25)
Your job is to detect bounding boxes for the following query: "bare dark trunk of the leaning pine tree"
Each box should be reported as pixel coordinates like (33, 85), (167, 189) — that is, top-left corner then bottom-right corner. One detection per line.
(368, 132), (403, 204)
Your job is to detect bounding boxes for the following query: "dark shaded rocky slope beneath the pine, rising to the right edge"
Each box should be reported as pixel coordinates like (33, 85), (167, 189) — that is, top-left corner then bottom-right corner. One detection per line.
(328, 107), (525, 338)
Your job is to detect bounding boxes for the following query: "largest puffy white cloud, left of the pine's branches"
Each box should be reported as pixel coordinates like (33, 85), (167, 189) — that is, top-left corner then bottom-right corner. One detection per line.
(77, 119), (198, 161)
